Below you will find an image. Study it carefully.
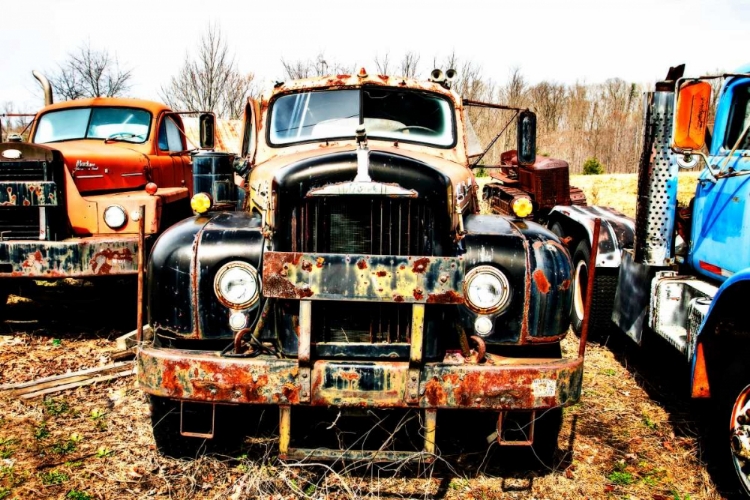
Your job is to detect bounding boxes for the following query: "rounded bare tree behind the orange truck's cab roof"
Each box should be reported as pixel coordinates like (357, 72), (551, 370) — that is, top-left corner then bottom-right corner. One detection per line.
(49, 43), (132, 100)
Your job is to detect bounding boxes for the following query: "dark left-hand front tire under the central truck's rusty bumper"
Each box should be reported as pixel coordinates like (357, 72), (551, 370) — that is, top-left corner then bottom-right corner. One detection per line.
(149, 396), (206, 458)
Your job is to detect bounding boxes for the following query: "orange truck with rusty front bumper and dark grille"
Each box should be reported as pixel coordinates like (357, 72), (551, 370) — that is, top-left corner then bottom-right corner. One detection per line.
(0, 73), (212, 303)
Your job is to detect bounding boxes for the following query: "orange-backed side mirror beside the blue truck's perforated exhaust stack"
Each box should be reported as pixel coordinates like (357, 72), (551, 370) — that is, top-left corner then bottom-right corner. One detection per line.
(672, 82), (711, 151)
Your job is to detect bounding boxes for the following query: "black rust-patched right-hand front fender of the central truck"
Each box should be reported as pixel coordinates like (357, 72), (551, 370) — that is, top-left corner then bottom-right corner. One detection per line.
(460, 215), (572, 344)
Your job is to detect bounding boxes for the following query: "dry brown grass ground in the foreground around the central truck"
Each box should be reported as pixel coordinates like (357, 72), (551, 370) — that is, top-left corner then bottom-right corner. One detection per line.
(0, 312), (720, 500)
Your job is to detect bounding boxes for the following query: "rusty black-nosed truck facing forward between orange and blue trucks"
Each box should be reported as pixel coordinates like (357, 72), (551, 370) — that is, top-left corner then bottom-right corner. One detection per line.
(137, 68), (583, 460)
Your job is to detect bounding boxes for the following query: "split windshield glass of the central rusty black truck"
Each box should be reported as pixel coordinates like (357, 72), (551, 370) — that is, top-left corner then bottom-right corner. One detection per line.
(269, 87), (455, 147)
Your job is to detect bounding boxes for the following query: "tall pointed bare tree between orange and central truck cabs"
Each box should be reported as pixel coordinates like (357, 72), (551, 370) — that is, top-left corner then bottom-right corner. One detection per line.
(159, 25), (255, 119)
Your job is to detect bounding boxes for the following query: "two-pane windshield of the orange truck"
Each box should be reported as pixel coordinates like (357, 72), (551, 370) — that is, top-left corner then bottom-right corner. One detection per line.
(33, 107), (151, 144)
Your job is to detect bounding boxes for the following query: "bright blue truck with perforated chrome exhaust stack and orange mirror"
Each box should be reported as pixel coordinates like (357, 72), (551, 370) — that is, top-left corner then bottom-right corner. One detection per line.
(549, 65), (750, 496)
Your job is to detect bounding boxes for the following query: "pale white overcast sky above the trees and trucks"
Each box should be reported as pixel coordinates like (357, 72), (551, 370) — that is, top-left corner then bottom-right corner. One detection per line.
(0, 0), (750, 111)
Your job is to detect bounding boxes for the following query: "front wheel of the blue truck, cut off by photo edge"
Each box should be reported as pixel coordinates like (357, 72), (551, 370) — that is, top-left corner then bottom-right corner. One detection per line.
(724, 365), (750, 496)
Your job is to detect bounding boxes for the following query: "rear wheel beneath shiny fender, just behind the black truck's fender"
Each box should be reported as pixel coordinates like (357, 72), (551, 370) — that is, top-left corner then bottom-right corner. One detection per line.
(570, 240), (617, 338)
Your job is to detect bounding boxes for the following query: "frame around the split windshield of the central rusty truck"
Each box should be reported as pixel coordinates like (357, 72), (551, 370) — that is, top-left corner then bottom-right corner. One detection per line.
(265, 84), (458, 149)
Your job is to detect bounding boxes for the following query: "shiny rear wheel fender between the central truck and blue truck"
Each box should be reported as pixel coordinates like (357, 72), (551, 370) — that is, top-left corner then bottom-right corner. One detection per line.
(547, 205), (635, 268)
